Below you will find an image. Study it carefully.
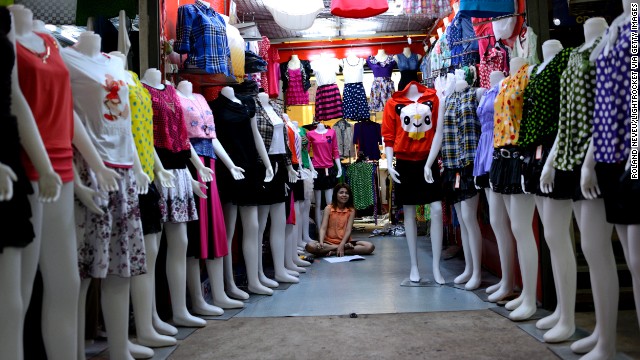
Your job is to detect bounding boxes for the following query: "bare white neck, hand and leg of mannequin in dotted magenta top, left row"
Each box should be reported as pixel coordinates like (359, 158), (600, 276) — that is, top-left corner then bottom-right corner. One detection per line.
(141, 68), (224, 327)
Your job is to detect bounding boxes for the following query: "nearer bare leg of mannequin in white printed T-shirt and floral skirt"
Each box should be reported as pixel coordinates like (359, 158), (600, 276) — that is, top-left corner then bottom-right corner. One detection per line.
(100, 275), (133, 360)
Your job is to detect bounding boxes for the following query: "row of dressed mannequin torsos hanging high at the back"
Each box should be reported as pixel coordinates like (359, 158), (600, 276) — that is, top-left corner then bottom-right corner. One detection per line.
(280, 47), (422, 121)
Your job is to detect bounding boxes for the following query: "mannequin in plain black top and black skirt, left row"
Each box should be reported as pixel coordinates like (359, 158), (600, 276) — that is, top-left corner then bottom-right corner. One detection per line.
(211, 86), (274, 300)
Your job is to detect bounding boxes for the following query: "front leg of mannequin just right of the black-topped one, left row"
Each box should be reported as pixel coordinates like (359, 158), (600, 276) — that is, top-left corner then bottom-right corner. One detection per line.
(269, 202), (300, 284)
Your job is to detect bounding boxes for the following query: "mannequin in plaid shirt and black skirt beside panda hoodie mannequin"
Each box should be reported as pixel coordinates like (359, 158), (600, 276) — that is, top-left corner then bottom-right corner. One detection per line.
(443, 70), (482, 290)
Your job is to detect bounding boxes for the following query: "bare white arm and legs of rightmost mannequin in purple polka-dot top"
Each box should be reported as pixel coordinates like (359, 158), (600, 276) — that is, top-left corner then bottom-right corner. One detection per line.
(571, 4), (640, 359)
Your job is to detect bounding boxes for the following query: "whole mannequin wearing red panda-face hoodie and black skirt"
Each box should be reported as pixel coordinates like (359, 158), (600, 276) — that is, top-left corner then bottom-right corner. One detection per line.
(382, 82), (445, 284)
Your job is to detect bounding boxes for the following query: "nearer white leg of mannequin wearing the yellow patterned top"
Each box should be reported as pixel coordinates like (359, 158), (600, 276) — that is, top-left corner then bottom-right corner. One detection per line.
(504, 194), (538, 321)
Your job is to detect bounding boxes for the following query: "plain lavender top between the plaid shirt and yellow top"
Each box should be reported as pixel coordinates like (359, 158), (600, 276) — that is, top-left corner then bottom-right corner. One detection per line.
(473, 83), (500, 176)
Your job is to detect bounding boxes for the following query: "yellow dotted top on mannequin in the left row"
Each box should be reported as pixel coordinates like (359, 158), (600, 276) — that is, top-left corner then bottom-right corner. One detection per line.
(129, 71), (155, 181)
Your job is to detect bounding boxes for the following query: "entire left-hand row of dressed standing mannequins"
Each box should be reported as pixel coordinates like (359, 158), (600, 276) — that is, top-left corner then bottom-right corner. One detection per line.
(0, 5), (350, 360)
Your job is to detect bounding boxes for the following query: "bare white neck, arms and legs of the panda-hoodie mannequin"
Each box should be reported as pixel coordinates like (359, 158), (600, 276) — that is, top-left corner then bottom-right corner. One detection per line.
(384, 85), (445, 284)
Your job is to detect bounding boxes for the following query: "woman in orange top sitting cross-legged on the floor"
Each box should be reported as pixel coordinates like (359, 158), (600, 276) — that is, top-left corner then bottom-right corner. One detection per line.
(306, 184), (375, 256)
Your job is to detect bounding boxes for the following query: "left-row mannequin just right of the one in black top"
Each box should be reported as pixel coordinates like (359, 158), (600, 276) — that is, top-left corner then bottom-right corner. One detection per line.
(256, 92), (299, 286)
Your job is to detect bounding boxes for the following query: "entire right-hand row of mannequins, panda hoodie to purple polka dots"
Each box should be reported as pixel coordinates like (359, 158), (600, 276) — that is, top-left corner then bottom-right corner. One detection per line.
(382, 1), (640, 359)
